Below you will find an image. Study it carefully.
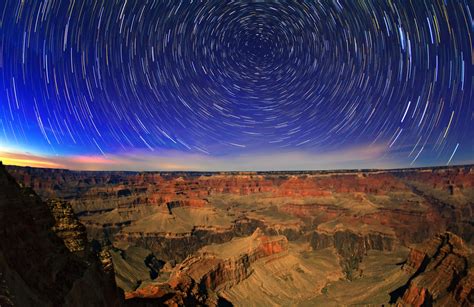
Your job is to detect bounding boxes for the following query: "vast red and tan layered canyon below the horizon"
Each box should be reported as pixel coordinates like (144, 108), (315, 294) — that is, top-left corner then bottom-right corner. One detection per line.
(0, 165), (474, 306)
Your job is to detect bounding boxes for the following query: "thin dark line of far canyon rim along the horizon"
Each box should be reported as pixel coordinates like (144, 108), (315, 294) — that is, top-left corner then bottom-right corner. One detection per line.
(0, 160), (474, 173)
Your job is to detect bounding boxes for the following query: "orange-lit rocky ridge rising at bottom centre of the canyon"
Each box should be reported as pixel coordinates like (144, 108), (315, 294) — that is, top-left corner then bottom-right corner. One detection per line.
(126, 229), (288, 305)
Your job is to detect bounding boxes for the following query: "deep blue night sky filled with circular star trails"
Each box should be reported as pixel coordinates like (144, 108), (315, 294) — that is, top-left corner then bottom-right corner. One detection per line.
(0, 0), (474, 170)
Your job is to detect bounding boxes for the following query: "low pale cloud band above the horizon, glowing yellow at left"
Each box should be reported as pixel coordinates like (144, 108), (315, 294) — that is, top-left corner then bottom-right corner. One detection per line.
(0, 145), (400, 171)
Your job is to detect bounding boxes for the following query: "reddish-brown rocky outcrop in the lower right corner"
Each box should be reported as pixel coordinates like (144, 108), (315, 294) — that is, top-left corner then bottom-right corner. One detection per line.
(393, 232), (474, 306)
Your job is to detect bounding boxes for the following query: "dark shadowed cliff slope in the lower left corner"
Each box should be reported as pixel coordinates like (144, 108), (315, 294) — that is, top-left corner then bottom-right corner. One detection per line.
(0, 164), (123, 306)
